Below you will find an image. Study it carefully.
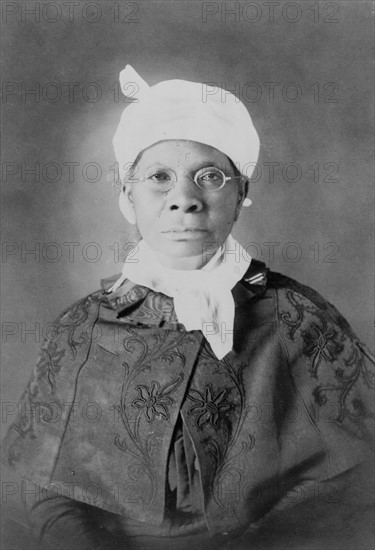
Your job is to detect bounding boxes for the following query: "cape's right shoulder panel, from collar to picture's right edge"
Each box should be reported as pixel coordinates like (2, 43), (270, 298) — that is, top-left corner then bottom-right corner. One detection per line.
(268, 273), (375, 444)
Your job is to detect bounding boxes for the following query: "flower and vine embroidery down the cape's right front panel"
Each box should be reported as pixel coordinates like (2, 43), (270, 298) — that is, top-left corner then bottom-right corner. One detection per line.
(183, 364), (255, 517)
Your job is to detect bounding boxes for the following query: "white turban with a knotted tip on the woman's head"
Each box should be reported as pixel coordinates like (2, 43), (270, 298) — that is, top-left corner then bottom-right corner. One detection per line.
(113, 65), (259, 180)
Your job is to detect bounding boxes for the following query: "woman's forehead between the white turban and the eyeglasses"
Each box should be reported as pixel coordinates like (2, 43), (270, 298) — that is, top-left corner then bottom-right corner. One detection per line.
(138, 139), (234, 167)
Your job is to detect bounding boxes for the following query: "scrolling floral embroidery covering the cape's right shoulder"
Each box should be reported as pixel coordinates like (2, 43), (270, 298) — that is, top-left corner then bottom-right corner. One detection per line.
(274, 275), (375, 437)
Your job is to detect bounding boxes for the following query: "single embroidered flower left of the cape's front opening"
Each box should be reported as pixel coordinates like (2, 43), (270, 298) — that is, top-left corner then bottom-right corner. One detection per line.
(132, 376), (182, 422)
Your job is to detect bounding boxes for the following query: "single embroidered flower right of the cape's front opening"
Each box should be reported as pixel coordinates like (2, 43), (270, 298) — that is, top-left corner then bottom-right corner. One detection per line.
(188, 384), (232, 430)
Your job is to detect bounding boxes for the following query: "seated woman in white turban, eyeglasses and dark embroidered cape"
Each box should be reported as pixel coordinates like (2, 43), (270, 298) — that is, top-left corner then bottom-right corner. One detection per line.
(4, 67), (374, 549)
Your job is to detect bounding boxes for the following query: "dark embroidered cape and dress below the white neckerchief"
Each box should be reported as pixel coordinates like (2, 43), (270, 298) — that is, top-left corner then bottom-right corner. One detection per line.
(4, 262), (374, 549)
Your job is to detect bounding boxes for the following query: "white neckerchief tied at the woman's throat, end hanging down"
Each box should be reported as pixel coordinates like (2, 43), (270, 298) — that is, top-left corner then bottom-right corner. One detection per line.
(110, 235), (251, 359)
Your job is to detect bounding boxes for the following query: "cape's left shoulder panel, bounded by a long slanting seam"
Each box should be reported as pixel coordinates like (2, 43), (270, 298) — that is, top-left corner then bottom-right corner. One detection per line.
(2, 291), (109, 483)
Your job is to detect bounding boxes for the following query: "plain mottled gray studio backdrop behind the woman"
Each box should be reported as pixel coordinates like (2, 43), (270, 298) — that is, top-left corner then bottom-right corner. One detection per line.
(1, 1), (373, 548)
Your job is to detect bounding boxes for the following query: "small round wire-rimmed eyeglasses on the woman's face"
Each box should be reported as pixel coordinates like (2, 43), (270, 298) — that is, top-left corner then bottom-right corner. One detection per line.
(135, 166), (242, 193)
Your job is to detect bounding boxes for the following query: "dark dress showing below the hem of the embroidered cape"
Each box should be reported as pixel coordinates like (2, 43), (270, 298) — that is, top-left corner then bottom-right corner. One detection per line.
(24, 467), (375, 550)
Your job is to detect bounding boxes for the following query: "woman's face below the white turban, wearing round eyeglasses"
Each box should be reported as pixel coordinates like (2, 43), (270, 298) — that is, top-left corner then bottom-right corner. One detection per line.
(125, 140), (244, 269)
